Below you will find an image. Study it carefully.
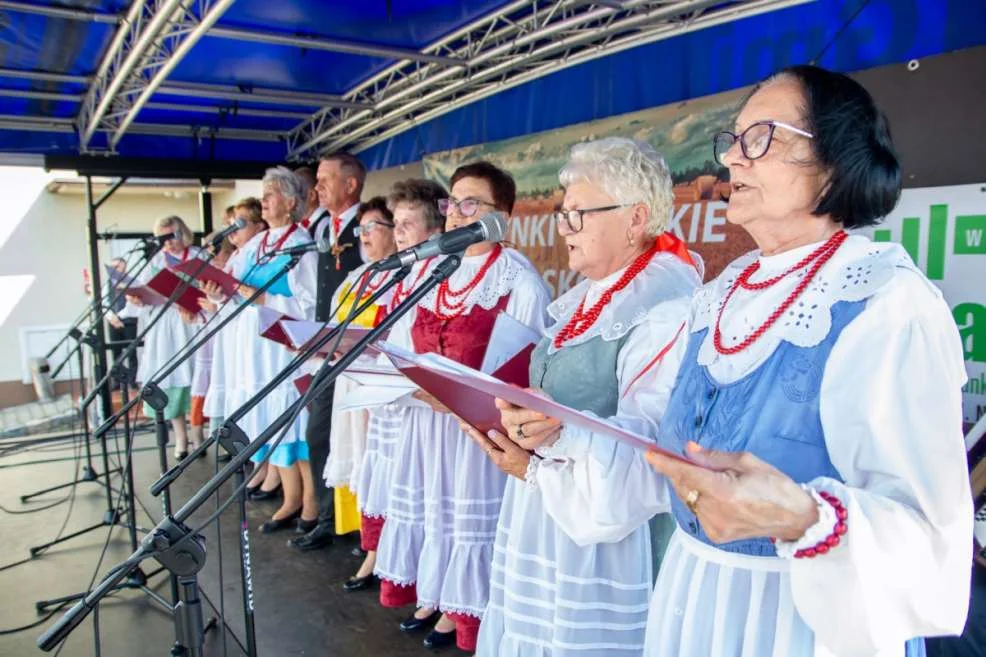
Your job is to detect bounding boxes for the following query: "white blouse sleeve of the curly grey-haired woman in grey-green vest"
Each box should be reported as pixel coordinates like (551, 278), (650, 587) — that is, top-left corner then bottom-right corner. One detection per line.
(535, 299), (689, 545)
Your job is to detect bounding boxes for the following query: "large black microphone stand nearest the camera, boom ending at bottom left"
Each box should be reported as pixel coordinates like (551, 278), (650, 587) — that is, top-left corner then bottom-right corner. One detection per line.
(37, 255), (462, 657)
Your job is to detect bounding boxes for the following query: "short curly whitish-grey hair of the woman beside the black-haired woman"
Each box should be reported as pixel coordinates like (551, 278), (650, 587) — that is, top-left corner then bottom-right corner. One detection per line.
(558, 137), (674, 237)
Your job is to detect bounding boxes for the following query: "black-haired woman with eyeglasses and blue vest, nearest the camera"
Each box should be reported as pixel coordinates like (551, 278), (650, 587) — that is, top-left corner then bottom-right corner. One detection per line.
(482, 66), (972, 657)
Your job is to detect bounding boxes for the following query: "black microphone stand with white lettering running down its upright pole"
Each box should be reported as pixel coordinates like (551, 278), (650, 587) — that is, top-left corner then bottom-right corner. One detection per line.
(150, 268), (411, 657)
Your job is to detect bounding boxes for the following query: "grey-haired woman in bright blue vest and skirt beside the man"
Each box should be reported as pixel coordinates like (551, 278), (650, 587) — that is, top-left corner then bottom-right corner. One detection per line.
(207, 167), (317, 533)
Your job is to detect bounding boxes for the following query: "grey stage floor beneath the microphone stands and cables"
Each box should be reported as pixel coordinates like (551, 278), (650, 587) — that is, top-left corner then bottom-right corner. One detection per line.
(0, 426), (446, 657)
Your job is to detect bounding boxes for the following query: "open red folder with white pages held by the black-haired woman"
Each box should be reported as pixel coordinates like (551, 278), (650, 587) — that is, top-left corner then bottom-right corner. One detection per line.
(377, 342), (694, 463)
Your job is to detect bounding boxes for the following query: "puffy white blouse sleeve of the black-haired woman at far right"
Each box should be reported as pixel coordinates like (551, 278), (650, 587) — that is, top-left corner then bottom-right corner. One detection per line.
(791, 271), (973, 655)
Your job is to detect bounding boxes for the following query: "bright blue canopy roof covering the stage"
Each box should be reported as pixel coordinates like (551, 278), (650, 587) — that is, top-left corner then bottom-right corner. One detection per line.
(0, 0), (986, 173)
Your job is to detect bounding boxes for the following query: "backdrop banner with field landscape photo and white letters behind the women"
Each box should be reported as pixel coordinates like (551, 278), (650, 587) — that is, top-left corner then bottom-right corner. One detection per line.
(423, 89), (754, 296)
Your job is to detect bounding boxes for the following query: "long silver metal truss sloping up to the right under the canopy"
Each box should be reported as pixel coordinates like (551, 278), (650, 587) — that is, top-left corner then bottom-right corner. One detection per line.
(287, 0), (812, 160)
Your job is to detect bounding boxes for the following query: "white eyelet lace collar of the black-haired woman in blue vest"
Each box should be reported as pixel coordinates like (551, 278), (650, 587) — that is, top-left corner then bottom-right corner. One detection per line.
(691, 235), (916, 371)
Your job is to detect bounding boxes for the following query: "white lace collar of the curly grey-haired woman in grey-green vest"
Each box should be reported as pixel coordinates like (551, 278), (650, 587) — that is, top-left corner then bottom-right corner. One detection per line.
(545, 253), (702, 353)
